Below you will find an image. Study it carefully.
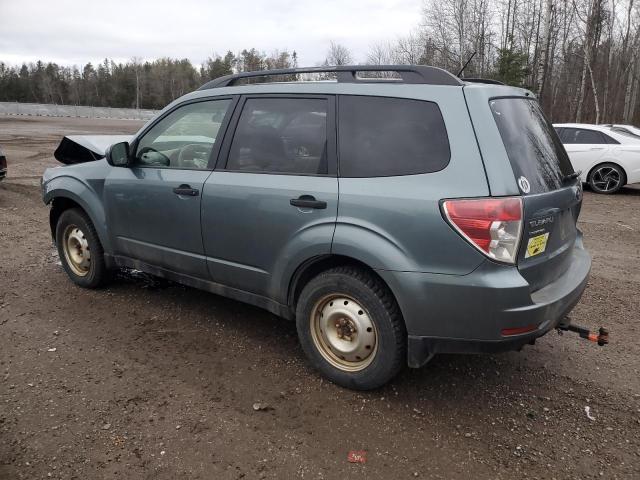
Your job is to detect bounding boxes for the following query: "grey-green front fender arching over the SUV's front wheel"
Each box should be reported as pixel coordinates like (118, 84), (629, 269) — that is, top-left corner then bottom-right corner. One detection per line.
(42, 176), (112, 253)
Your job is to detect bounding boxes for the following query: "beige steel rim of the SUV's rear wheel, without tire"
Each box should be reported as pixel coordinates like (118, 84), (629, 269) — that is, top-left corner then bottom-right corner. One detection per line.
(310, 294), (378, 372)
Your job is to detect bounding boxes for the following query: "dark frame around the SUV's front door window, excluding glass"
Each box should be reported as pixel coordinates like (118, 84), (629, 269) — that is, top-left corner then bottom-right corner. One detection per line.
(129, 95), (239, 172)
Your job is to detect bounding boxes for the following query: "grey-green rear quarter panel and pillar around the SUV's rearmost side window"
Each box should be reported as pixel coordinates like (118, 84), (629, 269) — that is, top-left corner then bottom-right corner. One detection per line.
(332, 86), (489, 275)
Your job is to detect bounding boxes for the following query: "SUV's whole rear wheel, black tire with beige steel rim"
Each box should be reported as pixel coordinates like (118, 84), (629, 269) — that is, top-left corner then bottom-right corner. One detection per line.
(296, 267), (406, 390)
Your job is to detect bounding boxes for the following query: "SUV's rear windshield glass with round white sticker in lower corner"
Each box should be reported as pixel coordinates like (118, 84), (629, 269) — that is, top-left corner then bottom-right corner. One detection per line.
(489, 98), (573, 194)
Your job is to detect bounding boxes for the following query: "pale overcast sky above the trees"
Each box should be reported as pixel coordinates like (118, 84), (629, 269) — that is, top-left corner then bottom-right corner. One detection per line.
(0, 0), (422, 66)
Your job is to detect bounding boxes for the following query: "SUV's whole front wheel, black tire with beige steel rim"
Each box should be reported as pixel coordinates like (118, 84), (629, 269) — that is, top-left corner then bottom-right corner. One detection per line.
(56, 208), (109, 288)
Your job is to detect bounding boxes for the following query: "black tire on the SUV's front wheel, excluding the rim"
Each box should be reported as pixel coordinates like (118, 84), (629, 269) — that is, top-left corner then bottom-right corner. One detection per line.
(56, 208), (111, 288)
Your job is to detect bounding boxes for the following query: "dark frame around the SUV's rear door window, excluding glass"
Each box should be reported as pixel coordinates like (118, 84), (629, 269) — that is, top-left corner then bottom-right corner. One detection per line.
(214, 93), (338, 178)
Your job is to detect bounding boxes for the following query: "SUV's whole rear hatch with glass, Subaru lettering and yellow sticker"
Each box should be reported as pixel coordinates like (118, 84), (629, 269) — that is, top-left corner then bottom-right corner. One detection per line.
(489, 97), (582, 292)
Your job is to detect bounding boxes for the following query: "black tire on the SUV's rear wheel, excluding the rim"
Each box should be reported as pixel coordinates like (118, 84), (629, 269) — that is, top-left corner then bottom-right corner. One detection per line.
(296, 266), (407, 390)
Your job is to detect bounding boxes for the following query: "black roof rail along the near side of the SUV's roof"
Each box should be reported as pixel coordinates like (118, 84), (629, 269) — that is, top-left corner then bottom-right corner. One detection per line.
(198, 65), (463, 90)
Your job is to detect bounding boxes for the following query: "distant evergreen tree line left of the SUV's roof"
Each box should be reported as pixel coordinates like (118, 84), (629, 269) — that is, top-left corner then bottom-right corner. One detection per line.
(0, 48), (298, 109)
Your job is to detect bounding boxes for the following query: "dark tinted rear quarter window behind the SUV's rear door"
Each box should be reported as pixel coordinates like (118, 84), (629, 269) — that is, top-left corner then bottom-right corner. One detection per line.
(338, 96), (451, 177)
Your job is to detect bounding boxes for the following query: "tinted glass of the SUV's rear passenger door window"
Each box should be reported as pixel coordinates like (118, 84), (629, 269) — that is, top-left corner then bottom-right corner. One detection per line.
(227, 98), (328, 175)
